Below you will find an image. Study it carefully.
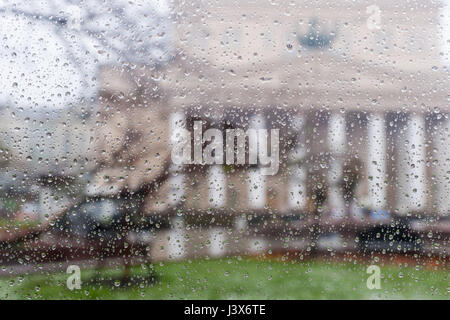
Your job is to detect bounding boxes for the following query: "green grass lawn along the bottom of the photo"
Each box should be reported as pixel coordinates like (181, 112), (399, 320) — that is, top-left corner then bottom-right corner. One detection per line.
(0, 258), (450, 299)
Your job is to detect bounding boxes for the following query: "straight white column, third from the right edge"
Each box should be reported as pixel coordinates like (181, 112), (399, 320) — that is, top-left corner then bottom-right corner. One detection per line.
(367, 114), (387, 210)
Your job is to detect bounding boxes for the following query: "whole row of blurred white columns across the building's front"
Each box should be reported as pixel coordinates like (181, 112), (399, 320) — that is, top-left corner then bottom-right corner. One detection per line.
(169, 112), (450, 218)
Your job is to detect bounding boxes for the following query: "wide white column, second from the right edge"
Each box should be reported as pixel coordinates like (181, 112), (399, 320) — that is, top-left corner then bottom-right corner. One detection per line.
(398, 115), (426, 214)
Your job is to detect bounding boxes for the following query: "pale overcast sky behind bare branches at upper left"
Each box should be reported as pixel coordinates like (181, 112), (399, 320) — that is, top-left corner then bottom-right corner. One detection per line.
(0, 0), (170, 110)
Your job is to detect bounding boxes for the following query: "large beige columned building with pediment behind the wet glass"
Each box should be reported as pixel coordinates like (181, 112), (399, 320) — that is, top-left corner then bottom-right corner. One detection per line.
(94, 0), (450, 222)
